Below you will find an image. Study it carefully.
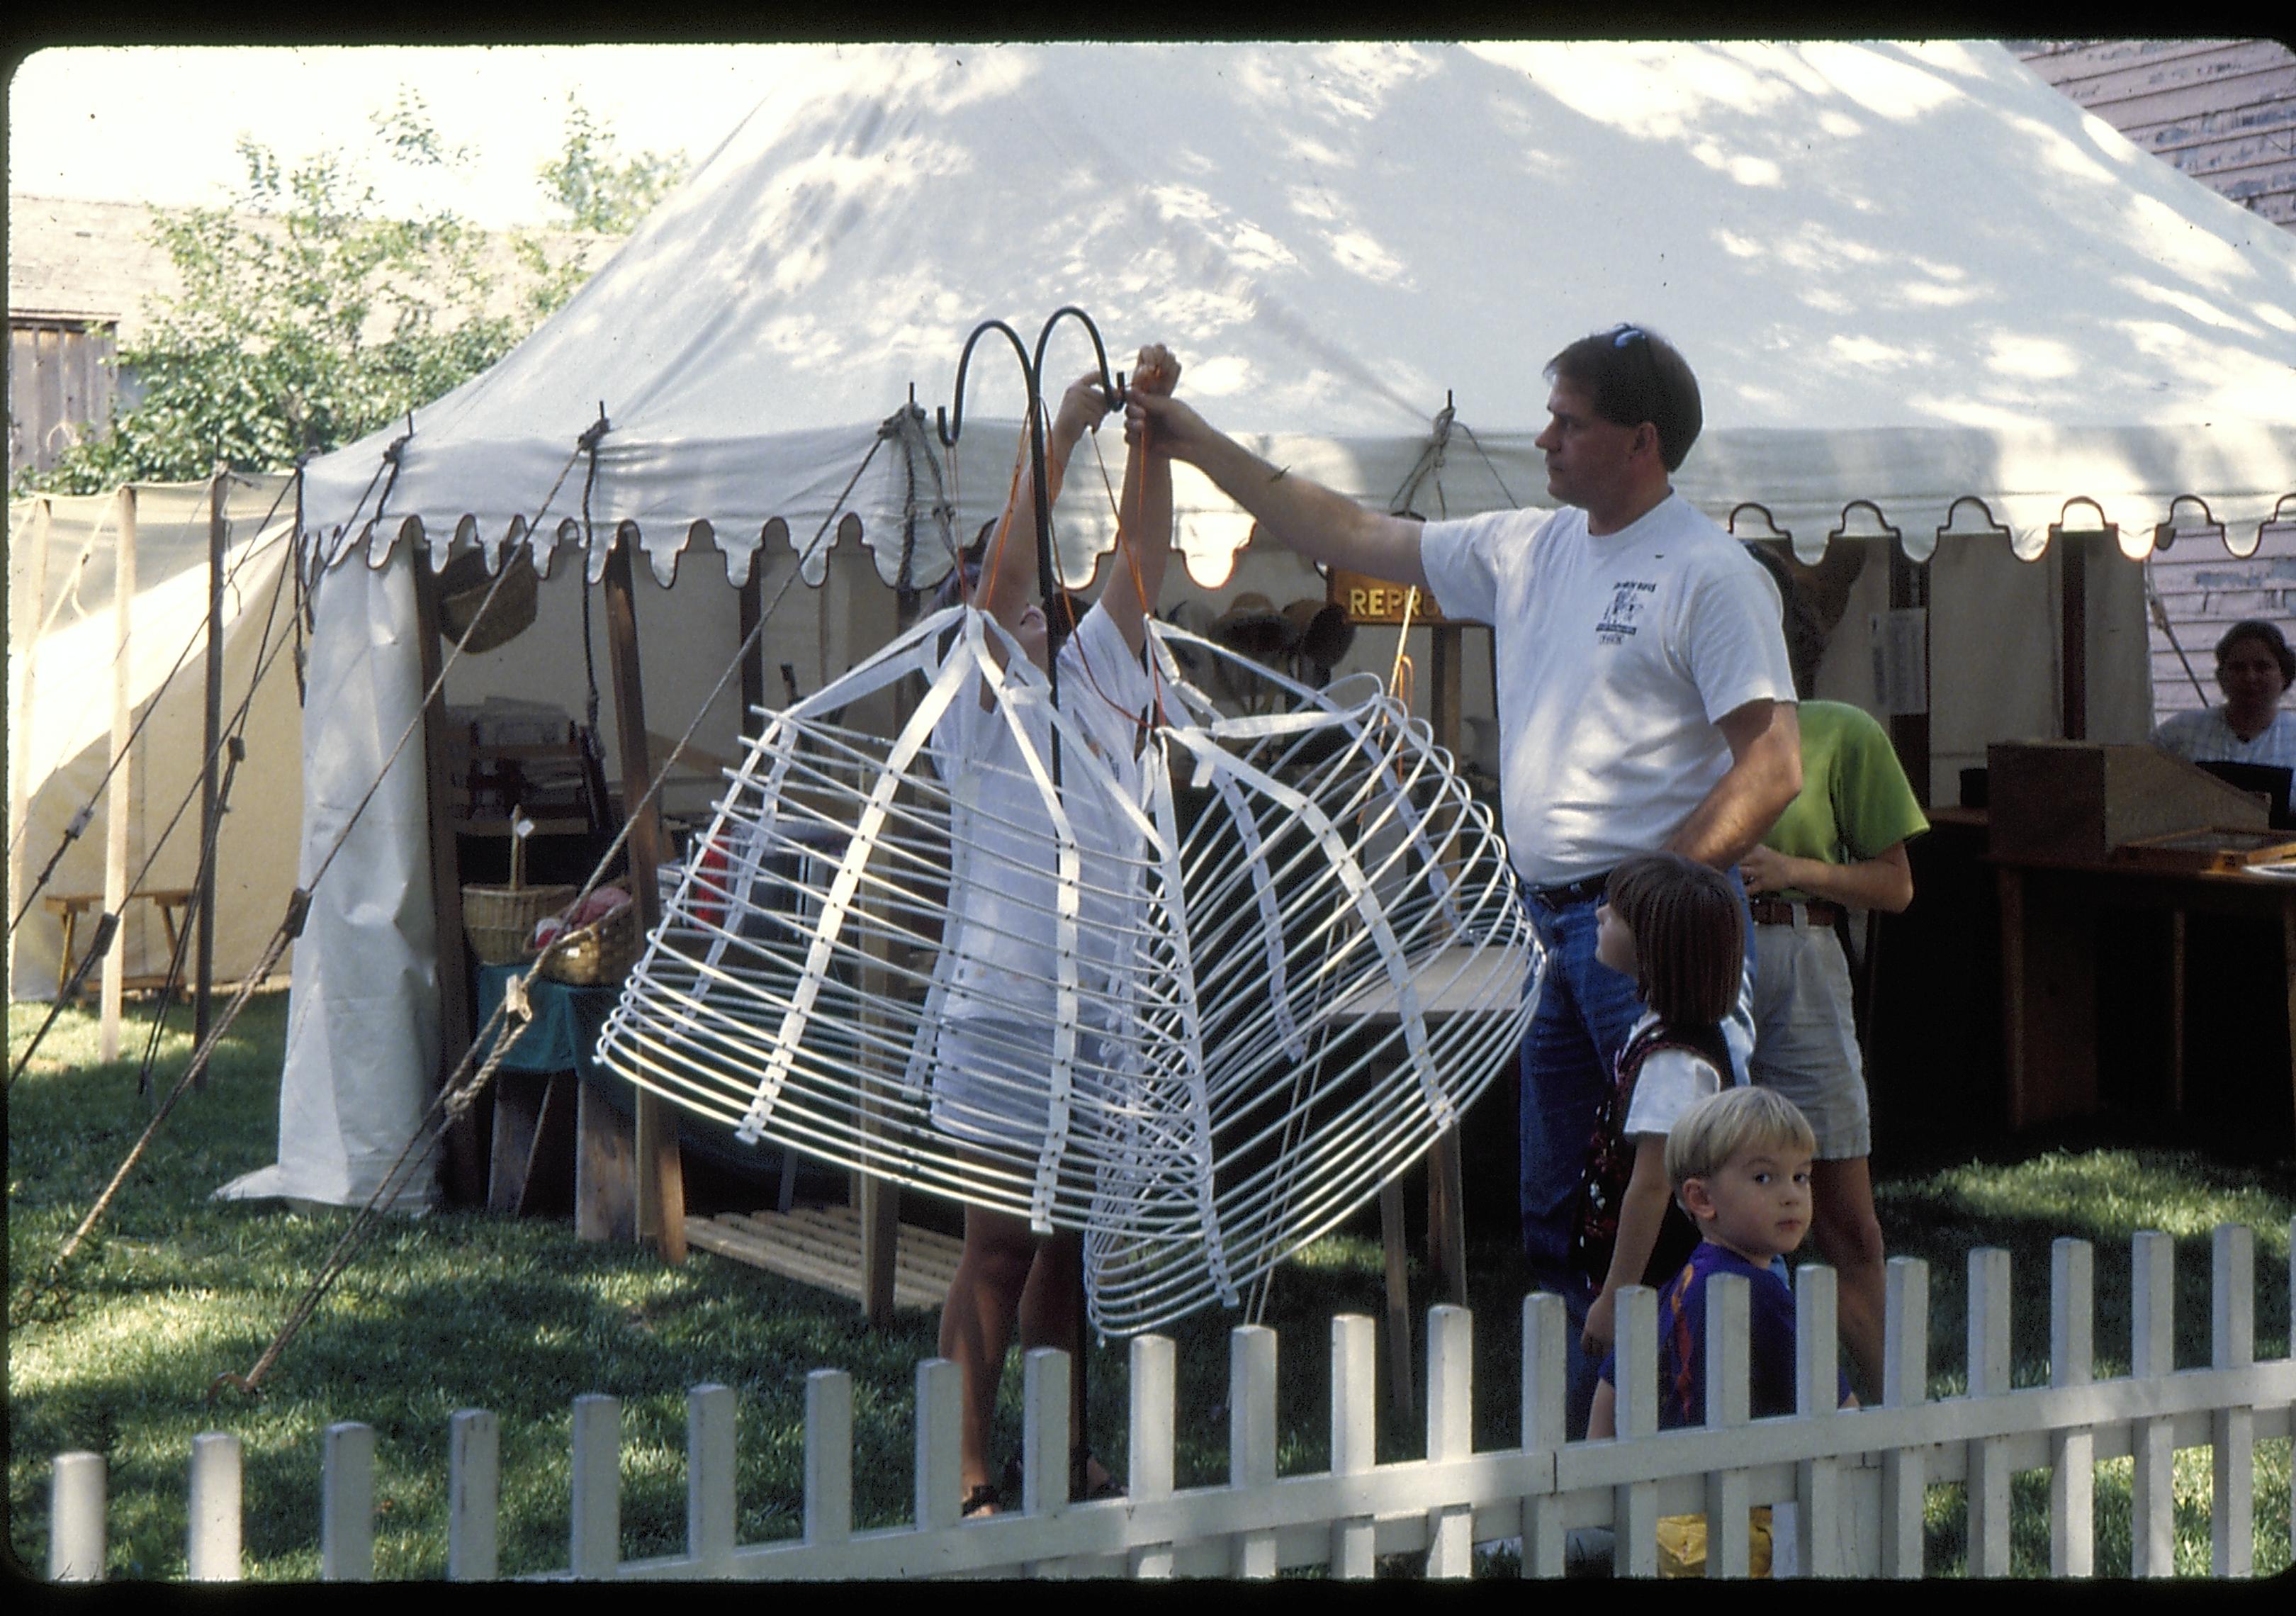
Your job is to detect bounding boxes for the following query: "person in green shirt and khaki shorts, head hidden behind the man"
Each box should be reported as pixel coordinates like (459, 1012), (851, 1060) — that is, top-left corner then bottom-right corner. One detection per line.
(1738, 700), (1929, 1396)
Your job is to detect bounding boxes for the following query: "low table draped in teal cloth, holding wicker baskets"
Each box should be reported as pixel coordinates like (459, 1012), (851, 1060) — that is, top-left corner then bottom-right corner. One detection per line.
(478, 964), (772, 1240)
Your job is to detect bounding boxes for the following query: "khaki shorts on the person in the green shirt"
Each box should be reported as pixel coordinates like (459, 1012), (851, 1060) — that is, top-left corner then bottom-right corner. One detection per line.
(1748, 907), (1874, 1162)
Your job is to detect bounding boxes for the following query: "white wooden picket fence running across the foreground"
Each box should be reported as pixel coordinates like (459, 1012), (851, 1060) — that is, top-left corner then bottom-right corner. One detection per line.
(35, 1223), (2296, 1581)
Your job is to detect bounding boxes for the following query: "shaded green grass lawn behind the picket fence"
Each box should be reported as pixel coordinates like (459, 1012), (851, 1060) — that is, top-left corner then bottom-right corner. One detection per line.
(9, 994), (2296, 1581)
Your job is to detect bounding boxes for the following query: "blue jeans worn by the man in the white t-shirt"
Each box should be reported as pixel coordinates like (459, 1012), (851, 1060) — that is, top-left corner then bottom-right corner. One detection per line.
(1520, 870), (1754, 1437)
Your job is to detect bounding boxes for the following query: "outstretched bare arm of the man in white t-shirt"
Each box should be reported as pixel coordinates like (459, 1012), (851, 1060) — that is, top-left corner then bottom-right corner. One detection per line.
(1125, 393), (1428, 588)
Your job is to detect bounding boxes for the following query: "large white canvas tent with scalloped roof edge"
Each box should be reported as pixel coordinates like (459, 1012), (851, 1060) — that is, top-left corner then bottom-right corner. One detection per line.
(237, 44), (2296, 1194)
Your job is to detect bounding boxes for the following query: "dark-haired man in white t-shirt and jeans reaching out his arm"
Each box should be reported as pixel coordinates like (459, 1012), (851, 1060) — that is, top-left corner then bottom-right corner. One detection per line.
(1127, 326), (1802, 1430)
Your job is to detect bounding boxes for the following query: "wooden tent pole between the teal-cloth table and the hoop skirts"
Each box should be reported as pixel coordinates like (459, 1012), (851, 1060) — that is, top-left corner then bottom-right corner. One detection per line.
(604, 528), (687, 1262)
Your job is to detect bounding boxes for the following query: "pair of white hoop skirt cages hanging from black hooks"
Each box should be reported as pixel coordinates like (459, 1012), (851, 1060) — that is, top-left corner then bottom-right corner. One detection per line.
(600, 606), (1543, 1334)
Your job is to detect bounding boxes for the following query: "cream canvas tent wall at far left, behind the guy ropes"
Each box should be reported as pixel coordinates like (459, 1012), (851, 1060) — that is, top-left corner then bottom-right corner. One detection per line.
(7, 475), (303, 999)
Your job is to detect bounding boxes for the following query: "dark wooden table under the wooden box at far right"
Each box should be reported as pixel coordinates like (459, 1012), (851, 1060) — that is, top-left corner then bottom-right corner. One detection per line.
(1991, 858), (2296, 1129)
